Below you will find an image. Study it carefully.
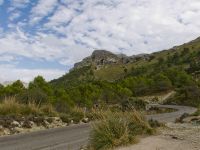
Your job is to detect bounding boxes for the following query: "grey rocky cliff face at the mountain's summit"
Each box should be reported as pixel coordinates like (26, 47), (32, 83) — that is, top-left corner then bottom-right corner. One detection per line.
(74, 50), (148, 70)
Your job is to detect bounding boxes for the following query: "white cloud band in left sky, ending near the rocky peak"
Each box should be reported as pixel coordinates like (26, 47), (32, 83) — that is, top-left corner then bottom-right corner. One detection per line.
(0, 28), (90, 65)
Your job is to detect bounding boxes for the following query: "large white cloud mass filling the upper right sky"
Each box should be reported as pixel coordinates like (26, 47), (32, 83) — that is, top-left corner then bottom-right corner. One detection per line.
(44, 0), (200, 55)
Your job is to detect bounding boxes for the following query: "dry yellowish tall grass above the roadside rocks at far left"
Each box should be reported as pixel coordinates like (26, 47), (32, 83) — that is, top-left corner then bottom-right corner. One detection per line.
(0, 97), (57, 116)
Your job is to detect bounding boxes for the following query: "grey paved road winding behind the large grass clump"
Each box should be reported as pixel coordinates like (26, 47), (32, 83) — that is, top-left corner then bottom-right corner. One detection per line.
(0, 105), (196, 150)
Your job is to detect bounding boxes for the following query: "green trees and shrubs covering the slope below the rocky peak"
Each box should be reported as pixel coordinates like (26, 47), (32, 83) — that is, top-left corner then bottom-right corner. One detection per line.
(0, 39), (200, 122)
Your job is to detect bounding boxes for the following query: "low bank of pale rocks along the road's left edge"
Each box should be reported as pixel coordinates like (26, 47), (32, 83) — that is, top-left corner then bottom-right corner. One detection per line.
(0, 116), (89, 136)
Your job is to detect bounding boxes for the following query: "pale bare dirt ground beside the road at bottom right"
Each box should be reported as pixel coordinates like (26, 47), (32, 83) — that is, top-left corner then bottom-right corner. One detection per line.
(118, 123), (200, 150)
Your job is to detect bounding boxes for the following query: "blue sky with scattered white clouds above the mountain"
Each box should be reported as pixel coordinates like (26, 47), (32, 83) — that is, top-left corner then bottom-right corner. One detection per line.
(0, 0), (200, 82)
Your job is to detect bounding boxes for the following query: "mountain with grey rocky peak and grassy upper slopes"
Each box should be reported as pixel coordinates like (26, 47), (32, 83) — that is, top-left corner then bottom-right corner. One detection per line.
(51, 38), (200, 85)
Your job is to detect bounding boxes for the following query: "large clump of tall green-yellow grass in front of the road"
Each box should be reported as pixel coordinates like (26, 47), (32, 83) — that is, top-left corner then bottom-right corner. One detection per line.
(90, 111), (153, 150)
